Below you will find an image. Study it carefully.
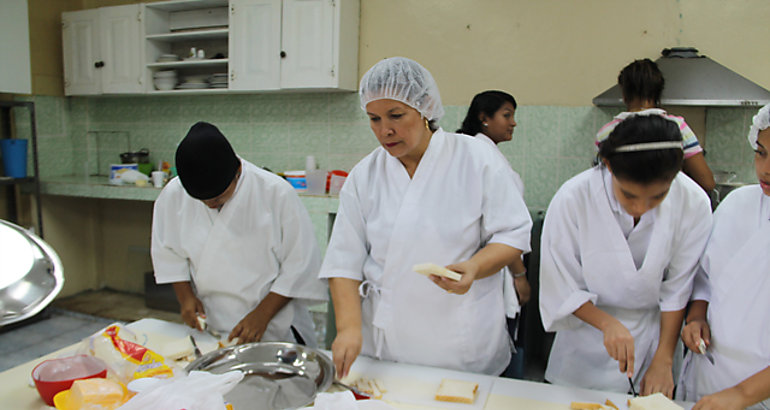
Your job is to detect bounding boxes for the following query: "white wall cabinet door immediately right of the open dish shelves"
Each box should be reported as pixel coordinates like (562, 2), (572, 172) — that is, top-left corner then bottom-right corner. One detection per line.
(229, 0), (281, 90)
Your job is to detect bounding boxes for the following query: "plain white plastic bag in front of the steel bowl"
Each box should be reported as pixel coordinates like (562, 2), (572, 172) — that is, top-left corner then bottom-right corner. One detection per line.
(120, 371), (243, 410)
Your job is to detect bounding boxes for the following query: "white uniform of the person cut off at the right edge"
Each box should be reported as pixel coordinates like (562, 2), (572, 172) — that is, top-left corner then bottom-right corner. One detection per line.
(677, 185), (770, 408)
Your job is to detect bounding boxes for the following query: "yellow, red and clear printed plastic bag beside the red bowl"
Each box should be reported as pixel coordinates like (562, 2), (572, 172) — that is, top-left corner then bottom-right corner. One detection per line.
(81, 324), (174, 384)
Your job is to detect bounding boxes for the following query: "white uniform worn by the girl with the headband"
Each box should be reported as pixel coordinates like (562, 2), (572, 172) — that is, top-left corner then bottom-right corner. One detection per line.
(540, 166), (711, 392)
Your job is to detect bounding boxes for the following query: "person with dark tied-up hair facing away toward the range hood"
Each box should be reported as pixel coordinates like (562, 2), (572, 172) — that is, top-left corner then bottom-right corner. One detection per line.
(596, 58), (716, 192)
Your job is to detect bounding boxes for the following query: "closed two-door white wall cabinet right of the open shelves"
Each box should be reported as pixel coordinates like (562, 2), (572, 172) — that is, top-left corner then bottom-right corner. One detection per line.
(230, 0), (360, 91)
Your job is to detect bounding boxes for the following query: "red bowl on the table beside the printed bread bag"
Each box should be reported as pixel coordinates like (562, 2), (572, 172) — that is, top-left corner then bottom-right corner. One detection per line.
(32, 355), (107, 406)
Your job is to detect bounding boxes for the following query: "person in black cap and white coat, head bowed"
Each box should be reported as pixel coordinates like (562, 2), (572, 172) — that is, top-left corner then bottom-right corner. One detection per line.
(151, 122), (328, 346)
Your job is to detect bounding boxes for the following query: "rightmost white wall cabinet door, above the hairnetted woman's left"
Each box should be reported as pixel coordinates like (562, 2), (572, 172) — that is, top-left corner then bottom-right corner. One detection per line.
(281, 0), (332, 88)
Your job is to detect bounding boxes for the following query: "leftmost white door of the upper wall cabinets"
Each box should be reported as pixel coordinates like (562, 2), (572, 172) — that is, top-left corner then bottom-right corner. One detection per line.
(62, 9), (101, 95)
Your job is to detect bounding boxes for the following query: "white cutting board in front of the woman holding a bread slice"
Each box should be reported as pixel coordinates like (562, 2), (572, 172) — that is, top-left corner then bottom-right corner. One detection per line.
(343, 356), (494, 410)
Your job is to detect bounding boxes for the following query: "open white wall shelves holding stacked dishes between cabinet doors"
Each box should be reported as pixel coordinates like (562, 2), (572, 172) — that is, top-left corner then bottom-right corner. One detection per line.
(145, 0), (230, 94)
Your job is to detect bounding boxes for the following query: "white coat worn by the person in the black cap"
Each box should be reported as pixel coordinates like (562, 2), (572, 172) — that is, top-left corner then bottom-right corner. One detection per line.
(152, 159), (328, 346)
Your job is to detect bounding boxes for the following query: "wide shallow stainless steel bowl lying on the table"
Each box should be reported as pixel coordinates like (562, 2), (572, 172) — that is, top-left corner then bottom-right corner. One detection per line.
(186, 342), (334, 410)
